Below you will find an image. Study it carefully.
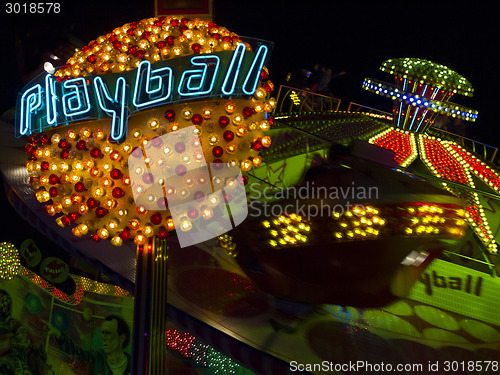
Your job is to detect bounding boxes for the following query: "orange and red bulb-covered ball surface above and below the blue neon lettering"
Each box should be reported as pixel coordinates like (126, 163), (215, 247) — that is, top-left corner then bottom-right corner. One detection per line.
(25, 17), (276, 246)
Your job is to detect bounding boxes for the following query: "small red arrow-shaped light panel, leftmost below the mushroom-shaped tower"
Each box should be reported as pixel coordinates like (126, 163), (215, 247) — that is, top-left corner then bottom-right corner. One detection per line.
(368, 128), (418, 167)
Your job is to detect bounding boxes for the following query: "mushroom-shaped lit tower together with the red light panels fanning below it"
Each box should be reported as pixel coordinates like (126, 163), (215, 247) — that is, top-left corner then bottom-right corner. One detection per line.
(363, 58), (500, 254)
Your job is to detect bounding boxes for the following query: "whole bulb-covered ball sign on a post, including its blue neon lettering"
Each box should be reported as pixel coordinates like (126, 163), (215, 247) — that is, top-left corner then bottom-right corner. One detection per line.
(21, 17), (276, 246)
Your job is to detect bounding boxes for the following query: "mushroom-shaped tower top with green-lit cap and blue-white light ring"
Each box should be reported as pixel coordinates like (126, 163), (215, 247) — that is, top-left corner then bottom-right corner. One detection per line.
(363, 58), (477, 133)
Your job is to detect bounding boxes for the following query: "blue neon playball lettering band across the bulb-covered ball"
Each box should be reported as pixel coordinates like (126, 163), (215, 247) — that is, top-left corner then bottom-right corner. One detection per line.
(16, 43), (269, 143)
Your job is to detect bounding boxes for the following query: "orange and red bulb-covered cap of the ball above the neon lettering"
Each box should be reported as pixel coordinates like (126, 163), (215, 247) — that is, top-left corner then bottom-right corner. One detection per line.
(55, 17), (250, 79)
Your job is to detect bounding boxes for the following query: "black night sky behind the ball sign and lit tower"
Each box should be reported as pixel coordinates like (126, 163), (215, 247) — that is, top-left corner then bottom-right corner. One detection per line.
(0, 0), (500, 146)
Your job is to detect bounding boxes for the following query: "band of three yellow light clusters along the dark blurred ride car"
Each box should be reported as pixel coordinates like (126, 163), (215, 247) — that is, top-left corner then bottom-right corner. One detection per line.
(256, 202), (467, 249)
